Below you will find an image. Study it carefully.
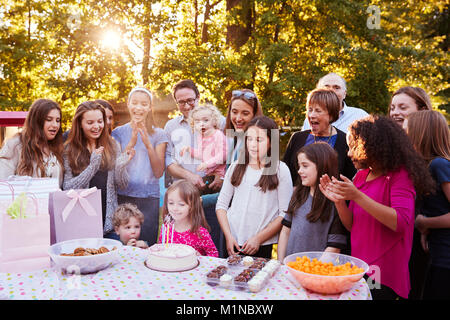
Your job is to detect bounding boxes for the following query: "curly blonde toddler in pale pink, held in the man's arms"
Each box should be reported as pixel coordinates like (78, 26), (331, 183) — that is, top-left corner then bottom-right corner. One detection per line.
(180, 104), (227, 194)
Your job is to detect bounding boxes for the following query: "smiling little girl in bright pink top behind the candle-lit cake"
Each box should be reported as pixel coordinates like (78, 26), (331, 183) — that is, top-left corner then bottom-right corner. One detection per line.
(159, 180), (219, 258)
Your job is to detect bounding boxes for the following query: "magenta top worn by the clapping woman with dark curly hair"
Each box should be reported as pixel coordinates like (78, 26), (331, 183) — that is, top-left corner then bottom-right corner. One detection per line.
(349, 168), (416, 298)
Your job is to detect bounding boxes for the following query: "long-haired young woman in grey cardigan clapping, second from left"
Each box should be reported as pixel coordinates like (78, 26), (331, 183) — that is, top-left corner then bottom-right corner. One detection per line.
(63, 101), (134, 235)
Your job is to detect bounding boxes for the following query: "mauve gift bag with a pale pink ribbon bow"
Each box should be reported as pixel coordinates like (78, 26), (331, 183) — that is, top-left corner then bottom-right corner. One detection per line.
(49, 187), (103, 244)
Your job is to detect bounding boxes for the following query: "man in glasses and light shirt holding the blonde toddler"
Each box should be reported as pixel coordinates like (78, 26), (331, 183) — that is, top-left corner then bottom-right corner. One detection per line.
(164, 79), (225, 255)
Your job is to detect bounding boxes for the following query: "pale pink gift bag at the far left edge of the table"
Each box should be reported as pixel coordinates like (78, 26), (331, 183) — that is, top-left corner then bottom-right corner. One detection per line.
(0, 182), (50, 273)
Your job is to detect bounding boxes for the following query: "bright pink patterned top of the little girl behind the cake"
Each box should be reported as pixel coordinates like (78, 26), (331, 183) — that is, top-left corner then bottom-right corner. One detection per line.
(159, 225), (219, 258)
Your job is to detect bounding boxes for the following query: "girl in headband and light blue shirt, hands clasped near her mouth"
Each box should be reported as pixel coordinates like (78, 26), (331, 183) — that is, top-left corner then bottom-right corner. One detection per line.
(112, 87), (168, 246)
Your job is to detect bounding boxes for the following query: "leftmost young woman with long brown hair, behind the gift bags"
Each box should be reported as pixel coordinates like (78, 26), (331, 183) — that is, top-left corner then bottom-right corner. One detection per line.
(0, 99), (63, 184)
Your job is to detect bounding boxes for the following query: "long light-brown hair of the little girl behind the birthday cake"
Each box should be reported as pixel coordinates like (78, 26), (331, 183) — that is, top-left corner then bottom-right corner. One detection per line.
(162, 179), (210, 236)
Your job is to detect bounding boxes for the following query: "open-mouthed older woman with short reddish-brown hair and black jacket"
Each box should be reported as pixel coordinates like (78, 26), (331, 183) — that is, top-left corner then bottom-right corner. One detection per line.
(283, 89), (356, 185)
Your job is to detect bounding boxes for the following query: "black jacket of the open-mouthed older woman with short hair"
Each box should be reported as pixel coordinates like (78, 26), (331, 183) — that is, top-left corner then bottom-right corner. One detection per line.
(283, 129), (356, 186)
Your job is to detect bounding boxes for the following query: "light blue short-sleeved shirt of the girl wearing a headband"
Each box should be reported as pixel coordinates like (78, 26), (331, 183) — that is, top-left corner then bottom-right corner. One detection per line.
(111, 123), (169, 198)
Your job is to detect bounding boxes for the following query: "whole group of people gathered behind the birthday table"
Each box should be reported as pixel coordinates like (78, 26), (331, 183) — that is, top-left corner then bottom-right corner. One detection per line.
(0, 73), (450, 299)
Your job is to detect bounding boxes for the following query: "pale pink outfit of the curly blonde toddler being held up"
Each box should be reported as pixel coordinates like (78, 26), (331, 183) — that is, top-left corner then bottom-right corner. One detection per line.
(192, 130), (227, 177)
